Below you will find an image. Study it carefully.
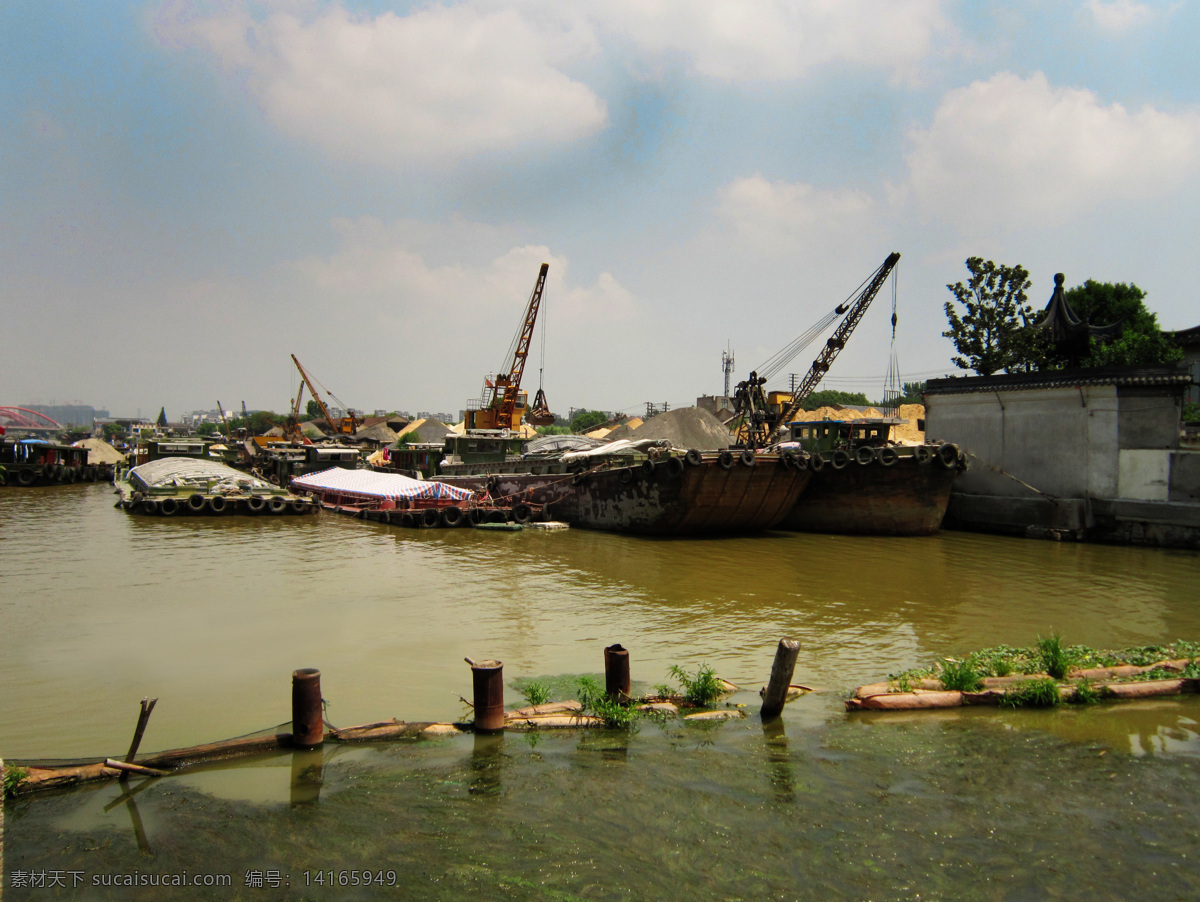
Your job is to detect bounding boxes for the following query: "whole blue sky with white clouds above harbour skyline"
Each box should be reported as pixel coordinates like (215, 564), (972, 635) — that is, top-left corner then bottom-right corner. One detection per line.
(0, 0), (1200, 417)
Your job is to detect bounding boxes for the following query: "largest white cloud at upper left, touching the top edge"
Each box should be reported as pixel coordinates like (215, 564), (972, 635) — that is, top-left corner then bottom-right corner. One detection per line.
(154, 0), (607, 166)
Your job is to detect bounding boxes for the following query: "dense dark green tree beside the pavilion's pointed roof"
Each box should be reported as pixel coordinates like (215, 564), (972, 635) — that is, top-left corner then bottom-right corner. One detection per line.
(1064, 279), (1183, 367)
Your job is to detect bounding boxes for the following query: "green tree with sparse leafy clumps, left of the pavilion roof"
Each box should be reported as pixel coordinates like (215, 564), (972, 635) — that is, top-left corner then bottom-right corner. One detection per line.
(942, 257), (1044, 375)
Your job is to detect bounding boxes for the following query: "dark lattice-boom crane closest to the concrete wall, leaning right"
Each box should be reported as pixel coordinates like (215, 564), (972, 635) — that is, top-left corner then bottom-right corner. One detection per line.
(736, 252), (900, 449)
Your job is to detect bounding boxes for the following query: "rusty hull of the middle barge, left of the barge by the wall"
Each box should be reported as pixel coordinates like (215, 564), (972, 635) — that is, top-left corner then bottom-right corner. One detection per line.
(547, 452), (811, 536)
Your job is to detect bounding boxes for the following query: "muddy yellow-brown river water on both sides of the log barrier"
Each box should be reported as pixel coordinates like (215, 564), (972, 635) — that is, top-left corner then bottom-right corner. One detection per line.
(7, 485), (1200, 900)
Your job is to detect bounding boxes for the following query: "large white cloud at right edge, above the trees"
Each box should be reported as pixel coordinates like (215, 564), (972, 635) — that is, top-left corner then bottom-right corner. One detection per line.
(906, 72), (1200, 227)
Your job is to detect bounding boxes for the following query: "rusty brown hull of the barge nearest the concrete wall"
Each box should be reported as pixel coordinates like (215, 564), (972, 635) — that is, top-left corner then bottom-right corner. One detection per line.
(779, 457), (958, 536)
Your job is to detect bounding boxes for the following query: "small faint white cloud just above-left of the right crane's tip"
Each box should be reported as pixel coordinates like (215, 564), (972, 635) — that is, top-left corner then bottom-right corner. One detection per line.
(716, 175), (877, 254)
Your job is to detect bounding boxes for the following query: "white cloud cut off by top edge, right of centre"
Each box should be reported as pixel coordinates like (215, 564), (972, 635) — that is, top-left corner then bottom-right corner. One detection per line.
(592, 0), (952, 82)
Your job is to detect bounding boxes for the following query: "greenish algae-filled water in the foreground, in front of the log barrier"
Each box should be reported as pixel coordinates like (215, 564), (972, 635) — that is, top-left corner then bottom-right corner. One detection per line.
(6, 704), (1200, 900)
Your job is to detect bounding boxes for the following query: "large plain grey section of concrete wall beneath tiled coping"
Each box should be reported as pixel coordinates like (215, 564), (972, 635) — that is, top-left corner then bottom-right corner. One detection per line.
(925, 385), (1120, 498)
